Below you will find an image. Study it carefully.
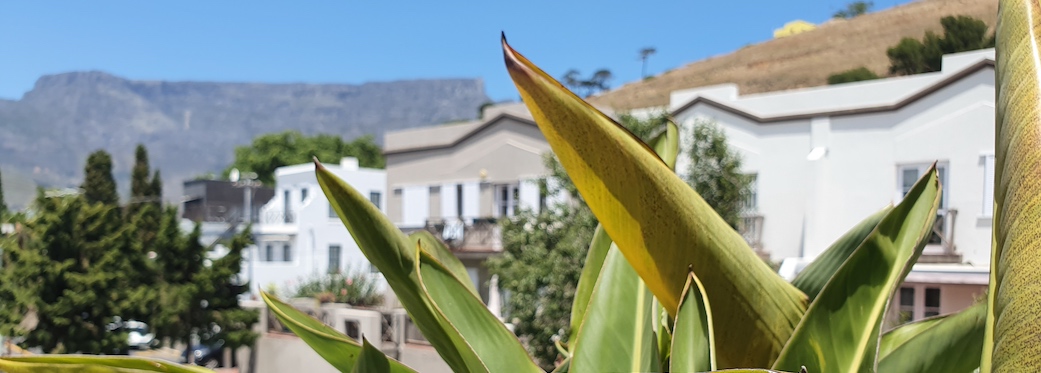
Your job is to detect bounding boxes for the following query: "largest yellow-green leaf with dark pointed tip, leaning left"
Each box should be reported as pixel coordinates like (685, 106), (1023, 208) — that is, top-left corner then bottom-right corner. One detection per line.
(503, 32), (806, 367)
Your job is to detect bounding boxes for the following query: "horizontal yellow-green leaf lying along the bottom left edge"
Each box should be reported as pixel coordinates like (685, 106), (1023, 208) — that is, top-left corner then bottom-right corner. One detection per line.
(0, 355), (212, 373)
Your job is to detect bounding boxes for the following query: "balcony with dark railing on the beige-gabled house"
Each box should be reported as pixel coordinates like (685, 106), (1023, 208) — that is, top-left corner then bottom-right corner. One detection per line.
(425, 218), (503, 252)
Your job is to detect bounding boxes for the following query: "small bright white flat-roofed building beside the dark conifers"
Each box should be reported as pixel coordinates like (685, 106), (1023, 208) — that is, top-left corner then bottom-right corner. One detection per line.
(243, 157), (386, 294)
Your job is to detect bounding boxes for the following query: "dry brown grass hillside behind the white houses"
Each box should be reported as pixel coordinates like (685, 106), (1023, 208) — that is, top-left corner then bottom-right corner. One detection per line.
(590, 0), (997, 109)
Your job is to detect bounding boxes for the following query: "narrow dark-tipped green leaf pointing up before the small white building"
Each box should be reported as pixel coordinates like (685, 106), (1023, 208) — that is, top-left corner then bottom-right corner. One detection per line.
(314, 161), (487, 372)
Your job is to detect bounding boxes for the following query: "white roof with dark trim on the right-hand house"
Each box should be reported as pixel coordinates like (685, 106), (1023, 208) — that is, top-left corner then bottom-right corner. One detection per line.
(670, 49), (994, 123)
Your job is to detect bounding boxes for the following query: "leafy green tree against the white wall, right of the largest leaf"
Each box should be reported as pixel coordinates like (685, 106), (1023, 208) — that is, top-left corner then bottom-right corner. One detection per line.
(686, 120), (752, 228)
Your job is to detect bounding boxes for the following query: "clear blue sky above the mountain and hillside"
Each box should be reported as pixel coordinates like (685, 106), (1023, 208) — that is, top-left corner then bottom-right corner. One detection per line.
(0, 0), (906, 100)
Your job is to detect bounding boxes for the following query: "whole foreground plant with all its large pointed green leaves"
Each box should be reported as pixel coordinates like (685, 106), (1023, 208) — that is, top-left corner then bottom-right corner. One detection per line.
(0, 1), (1041, 372)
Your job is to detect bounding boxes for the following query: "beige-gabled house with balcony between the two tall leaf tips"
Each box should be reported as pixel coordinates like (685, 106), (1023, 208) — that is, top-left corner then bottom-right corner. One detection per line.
(383, 104), (554, 301)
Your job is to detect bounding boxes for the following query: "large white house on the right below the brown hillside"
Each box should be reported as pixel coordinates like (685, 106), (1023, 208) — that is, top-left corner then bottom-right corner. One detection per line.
(644, 49), (994, 327)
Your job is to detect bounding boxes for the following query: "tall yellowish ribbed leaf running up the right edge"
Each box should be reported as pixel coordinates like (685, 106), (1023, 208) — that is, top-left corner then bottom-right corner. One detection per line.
(981, 1), (1041, 372)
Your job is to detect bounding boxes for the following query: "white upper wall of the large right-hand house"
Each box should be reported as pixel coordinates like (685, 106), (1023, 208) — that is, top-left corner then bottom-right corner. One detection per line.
(676, 69), (994, 264)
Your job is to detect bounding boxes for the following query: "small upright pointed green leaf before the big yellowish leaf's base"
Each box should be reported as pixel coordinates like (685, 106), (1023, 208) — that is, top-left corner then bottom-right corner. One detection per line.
(670, 273), (716, 372)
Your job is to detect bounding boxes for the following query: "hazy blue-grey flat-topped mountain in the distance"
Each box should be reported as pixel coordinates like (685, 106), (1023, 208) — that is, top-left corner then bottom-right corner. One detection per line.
(0, 71), (489, 205)
